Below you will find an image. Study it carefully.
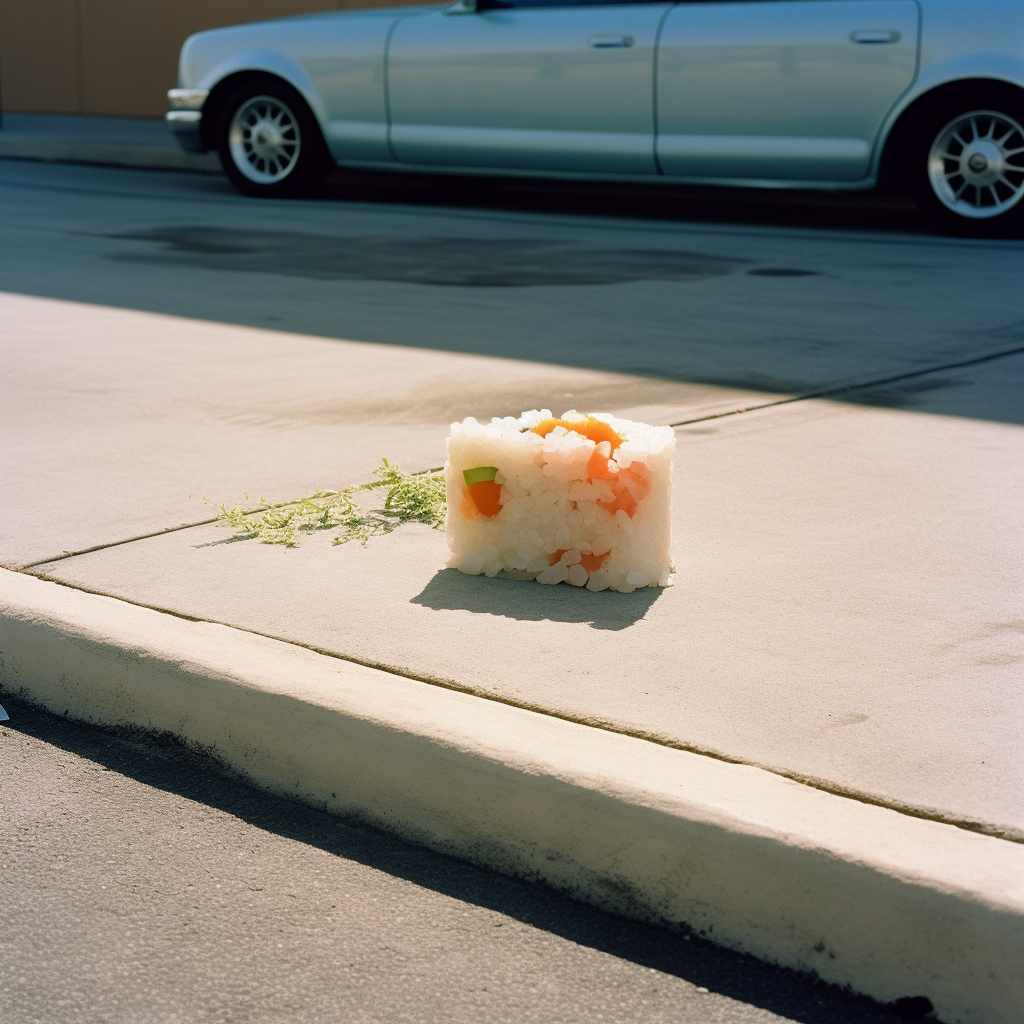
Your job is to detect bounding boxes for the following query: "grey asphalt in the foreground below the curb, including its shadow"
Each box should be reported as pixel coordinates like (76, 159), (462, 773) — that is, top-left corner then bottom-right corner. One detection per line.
(0, 697), (933, 1024)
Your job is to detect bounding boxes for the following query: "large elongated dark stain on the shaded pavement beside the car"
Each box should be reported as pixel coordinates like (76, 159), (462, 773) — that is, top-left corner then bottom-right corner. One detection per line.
(106, 226), (746, 288)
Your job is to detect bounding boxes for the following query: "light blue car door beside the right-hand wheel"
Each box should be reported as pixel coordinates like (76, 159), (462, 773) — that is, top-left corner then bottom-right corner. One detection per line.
(657, 0), (919, 181)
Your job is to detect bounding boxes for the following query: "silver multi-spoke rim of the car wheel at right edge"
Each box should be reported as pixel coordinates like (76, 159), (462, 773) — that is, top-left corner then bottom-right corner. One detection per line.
(928, 111), (1024, 220)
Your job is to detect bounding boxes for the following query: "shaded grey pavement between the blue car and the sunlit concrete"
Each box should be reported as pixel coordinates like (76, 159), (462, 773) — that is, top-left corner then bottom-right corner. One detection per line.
(0, 161), (1024, 401)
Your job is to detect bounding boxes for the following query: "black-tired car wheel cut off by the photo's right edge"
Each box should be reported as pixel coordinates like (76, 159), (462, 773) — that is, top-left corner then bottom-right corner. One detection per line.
(907, 85), (1024, 238)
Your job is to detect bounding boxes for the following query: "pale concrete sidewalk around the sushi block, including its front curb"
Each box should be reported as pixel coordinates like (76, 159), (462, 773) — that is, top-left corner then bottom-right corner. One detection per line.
(0, 288), (1024, 1024)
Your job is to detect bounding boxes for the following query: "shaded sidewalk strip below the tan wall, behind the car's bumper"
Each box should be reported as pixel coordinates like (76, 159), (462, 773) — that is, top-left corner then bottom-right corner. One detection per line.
(0, 113), (221, 174)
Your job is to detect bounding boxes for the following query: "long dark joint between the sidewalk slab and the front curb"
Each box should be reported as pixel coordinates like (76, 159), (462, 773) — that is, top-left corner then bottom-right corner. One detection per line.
(14, 569), (1024, 845)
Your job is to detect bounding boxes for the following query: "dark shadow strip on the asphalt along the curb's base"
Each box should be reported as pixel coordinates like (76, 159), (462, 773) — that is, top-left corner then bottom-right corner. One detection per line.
(0, 693), (927, 1024)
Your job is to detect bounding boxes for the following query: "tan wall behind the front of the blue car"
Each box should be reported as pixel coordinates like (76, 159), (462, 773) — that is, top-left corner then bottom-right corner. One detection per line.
(0, 0), (415, 117)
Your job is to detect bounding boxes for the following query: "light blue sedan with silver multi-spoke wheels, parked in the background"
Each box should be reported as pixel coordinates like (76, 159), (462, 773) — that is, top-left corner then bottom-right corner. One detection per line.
(167, 0), (1024, 231)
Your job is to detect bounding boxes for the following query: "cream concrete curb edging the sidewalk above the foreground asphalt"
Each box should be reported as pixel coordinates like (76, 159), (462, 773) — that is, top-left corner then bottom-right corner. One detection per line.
(0, 570), (1024, 1024)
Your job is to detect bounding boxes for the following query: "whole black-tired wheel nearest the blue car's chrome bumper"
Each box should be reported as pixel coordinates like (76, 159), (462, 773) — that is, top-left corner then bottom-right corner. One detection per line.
(216, 75), (333, 199)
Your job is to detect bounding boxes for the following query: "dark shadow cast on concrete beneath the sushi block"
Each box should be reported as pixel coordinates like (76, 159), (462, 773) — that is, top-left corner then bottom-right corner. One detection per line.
(411, 569), (665, 630)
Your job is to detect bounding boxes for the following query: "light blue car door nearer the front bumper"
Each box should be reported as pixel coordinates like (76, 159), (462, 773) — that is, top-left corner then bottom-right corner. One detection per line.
(387, 0), (670, 174)
